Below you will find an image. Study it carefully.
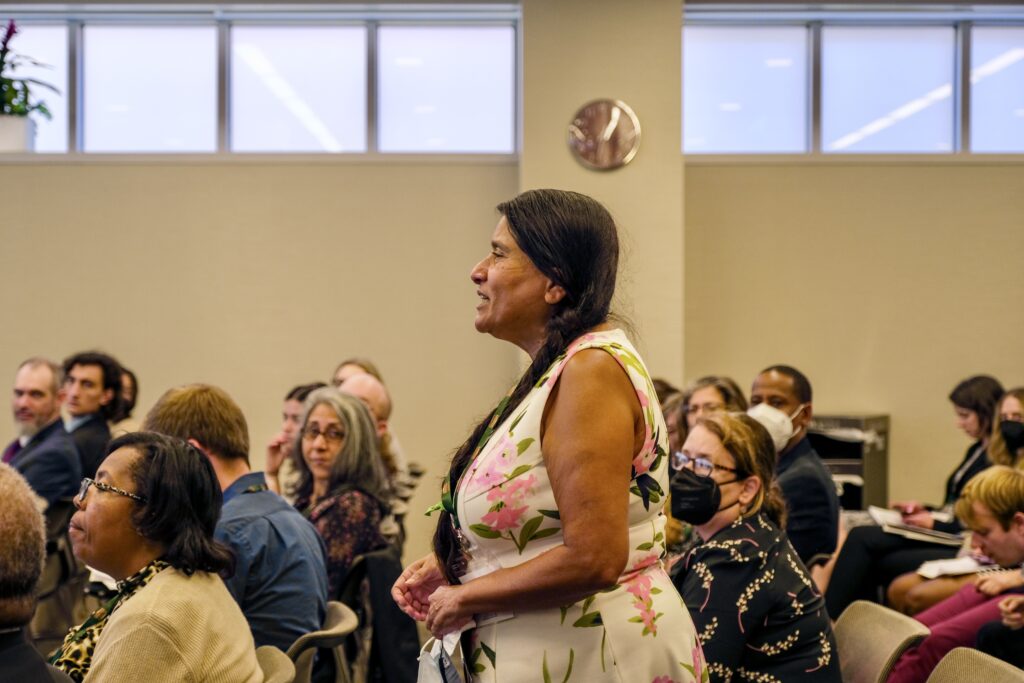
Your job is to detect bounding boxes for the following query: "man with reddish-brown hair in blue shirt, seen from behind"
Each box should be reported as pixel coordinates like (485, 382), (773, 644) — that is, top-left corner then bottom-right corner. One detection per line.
(143, 384), (328, 650)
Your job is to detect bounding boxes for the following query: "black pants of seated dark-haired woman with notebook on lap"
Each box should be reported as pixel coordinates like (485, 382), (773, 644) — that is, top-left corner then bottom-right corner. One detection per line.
(825, 526), (956, 618)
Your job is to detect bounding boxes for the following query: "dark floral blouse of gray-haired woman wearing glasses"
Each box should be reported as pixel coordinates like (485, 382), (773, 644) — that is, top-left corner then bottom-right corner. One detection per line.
(295, 488), (387, 600)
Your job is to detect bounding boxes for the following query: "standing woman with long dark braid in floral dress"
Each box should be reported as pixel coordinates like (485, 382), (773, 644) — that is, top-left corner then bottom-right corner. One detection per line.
(392, 189), (707, 683)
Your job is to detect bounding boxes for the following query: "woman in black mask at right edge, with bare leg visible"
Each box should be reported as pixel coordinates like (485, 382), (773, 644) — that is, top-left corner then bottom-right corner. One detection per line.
(886, 387), (1024, 614)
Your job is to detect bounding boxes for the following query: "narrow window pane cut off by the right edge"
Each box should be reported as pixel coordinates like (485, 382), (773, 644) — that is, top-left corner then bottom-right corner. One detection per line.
(971, 27), (1024, 153)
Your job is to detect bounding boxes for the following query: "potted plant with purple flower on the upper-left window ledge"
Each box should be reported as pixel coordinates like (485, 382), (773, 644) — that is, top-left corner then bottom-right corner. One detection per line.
(0, 19), (59, 152)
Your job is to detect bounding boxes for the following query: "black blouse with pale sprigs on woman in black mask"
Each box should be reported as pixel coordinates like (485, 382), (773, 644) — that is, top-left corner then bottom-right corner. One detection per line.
(673, 513), (841, 683)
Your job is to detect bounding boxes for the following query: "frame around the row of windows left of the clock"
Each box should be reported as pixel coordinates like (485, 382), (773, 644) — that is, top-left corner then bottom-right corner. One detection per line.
(0, 4), (522, 158)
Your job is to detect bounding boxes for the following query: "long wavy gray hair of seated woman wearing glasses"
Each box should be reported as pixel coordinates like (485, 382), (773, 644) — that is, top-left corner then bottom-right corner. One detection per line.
(293, 387), (390, 504)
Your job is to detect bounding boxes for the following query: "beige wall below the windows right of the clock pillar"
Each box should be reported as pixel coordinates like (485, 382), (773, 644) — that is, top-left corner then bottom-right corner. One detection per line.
(686, 160), (1024, 503)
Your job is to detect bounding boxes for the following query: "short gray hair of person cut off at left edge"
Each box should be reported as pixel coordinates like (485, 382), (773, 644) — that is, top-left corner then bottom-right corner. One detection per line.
(0, 464), (46, 628)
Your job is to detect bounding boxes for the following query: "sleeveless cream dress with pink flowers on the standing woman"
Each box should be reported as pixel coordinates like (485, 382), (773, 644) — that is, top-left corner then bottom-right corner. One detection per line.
(456, 330), (708, 683)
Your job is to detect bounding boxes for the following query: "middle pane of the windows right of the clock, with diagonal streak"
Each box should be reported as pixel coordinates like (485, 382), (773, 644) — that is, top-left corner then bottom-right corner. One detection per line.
(821, 26), (955, 153)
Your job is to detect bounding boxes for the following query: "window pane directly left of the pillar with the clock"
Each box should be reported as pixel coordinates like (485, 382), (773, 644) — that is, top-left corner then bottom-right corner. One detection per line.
(378, 27), (515, 153)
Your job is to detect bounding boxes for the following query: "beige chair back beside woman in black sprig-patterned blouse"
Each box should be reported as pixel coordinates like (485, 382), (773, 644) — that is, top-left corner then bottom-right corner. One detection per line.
(835, 600), (931, 683)
